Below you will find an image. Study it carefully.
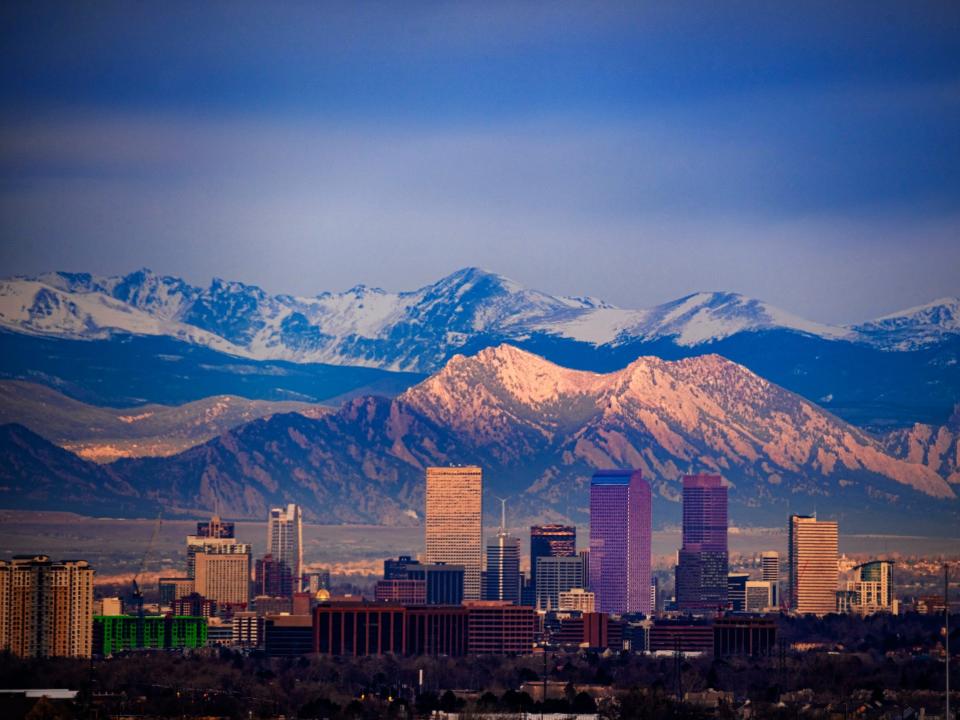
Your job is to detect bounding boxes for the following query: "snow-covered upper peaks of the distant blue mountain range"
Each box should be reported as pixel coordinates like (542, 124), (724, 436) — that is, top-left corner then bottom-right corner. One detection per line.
(0, 268), (960, 372)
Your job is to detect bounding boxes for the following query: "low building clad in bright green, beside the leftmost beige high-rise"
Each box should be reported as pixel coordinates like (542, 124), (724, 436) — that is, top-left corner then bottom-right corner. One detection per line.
(93, 615), (207, 656)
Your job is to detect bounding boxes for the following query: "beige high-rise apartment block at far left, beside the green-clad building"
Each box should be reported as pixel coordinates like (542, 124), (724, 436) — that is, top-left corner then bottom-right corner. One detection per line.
(0, 555), (93, 657)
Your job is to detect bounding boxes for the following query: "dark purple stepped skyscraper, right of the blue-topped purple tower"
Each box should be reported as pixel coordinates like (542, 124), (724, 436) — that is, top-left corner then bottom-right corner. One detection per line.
(676, 474), (728, 610)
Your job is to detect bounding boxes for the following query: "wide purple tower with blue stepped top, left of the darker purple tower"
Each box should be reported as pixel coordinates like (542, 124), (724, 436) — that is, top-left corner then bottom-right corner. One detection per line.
(590, 470), (652, 615)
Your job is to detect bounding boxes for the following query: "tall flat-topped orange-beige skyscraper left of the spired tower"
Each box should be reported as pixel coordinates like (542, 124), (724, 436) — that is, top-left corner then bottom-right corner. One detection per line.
(425, 465), (483, 600)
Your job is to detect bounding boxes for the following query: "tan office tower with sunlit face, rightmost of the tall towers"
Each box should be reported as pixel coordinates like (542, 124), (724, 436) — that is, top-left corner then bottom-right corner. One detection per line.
(788, 515), (839, 615)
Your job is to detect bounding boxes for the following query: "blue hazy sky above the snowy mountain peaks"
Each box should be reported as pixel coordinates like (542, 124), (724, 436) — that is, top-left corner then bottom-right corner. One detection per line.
(0, 1), (960, 323)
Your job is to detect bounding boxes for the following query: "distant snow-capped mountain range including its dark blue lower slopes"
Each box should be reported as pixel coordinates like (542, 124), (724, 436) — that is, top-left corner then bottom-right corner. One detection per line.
(0, 268), (960, 427)
